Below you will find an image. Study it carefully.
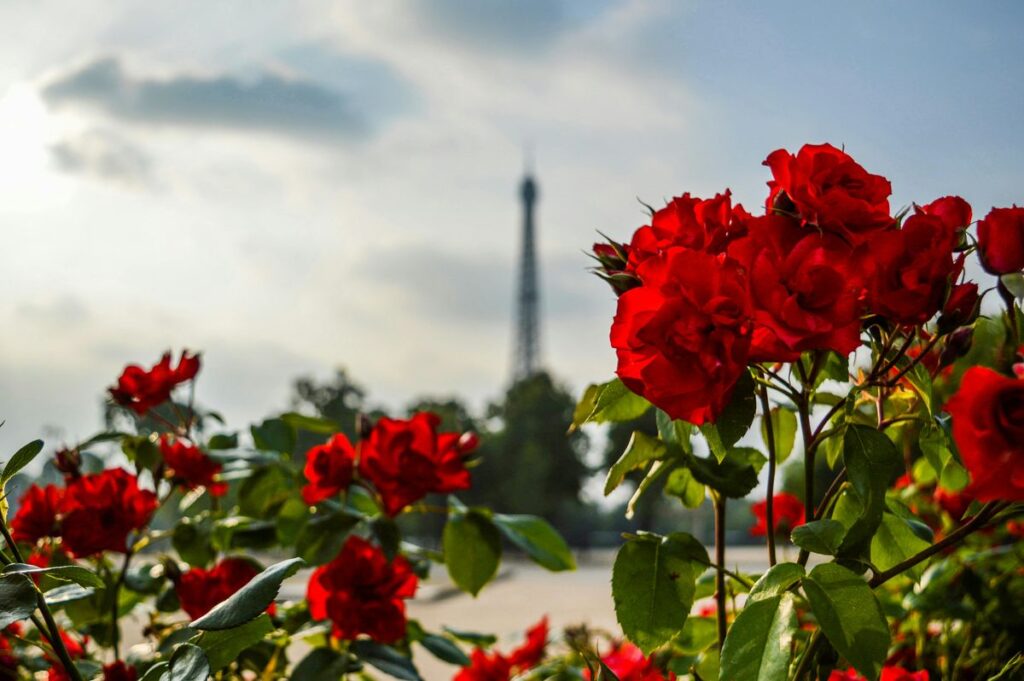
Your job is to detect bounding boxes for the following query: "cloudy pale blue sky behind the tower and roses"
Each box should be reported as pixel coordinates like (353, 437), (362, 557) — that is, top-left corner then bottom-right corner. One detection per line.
(0, 0), (1024, 456)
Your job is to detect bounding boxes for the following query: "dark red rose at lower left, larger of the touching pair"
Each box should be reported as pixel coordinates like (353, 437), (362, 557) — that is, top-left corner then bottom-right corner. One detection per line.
(60, 468), (157, 558)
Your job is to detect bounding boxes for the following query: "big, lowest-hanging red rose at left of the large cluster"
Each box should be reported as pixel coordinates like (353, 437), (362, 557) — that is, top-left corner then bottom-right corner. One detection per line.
(611, 248), (753, 425)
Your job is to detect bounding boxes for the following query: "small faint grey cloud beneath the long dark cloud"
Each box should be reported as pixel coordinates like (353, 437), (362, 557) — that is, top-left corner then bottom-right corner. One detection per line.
(50, 129), (152, 184)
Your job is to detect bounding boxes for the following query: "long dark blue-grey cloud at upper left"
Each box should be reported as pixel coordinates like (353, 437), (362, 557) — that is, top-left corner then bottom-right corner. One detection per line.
(42, 57), (369, 139)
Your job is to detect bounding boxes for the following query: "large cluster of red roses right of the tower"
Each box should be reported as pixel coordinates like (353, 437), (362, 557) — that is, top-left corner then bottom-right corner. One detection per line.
(595, 144), (995, 425)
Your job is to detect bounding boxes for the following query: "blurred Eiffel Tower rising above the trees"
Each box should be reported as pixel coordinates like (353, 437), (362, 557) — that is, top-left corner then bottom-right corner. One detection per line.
(512, 163), (541, 382)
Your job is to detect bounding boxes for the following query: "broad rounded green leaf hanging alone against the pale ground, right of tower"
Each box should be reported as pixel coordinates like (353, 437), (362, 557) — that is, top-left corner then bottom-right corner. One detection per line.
(611, 533), (709, 654)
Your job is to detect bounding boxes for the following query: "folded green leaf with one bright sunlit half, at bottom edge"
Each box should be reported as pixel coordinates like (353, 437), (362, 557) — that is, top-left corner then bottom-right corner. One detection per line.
(719, 593), (797, 681)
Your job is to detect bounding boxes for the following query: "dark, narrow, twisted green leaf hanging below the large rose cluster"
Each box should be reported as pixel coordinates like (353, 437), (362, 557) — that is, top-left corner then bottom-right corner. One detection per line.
(839, 425), (901, 557)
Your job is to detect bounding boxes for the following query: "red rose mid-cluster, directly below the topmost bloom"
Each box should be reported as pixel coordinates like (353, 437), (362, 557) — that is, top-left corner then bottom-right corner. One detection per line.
(728, 215), (863, 361)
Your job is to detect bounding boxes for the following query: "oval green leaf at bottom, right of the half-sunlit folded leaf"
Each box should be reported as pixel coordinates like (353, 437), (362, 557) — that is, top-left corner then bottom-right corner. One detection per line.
(804, 563), (889, 679)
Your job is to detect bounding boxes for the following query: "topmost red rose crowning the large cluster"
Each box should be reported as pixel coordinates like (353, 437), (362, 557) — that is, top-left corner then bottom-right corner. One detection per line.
(764, 144), (893, 242)
